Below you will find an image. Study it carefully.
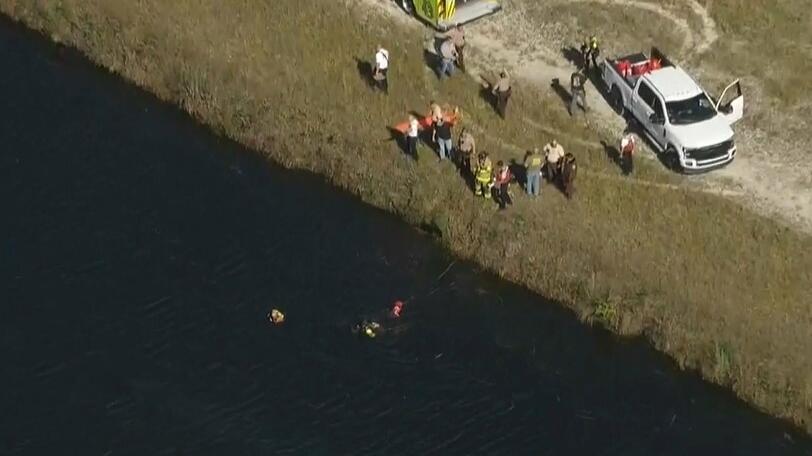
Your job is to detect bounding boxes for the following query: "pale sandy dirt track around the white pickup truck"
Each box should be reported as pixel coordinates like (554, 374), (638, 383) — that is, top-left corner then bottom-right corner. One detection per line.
(363, 0), (812, 233)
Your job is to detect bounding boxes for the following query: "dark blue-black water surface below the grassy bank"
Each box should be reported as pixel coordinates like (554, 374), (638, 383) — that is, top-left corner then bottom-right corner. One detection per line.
(0, 16), (812, 455)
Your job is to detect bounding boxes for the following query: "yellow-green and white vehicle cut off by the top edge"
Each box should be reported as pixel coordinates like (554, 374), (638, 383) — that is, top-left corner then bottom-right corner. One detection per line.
(399, 0), (502, 31)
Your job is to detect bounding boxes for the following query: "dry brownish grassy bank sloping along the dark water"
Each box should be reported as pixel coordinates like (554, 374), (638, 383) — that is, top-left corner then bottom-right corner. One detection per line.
(6, 0), (812, 430)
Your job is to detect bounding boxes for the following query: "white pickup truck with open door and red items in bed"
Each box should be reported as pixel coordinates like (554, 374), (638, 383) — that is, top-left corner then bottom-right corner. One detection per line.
(600, 48), (744, 172)
